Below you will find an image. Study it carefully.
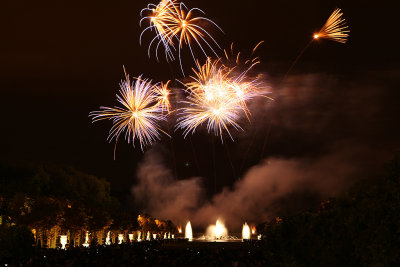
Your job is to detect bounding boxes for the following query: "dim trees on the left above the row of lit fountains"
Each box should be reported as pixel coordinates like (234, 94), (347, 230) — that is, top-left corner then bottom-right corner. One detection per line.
(0, 164), (112, 231)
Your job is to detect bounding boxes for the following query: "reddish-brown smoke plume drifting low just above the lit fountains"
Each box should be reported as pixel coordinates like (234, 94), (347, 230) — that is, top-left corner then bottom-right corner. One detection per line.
(132, 143), (369, 229)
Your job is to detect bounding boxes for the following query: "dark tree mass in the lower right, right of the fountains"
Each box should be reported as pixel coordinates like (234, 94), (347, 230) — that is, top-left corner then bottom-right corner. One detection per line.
(264, 159), (400, 266)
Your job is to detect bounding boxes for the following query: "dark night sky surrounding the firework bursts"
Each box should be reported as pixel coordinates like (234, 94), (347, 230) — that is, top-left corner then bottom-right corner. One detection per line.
(0, 0), (400, 205)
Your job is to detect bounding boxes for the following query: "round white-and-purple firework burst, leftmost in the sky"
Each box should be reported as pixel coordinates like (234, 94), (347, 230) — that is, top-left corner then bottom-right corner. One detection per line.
(89, 75), (169, 153)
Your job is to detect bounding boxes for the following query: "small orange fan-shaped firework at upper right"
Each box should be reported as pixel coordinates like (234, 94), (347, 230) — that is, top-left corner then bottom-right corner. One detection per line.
(314, 8), (350, 43)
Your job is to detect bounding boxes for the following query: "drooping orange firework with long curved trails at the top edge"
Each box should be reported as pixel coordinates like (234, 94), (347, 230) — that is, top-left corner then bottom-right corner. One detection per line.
(139, 0), (223, 74)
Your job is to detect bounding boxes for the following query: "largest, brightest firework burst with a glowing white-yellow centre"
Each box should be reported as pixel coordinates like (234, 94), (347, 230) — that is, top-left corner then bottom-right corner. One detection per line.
(177, 52), (263, 140)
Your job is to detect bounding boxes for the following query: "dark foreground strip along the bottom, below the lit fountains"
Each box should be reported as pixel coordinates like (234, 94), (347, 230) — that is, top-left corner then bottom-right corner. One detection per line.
(18, 241), (265, 266)
